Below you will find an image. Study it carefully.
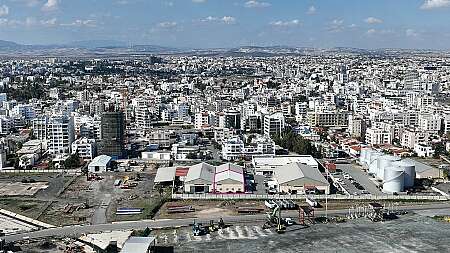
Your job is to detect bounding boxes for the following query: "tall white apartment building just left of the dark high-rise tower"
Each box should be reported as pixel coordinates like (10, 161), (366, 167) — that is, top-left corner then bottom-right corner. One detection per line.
(33, 115), (75, 155)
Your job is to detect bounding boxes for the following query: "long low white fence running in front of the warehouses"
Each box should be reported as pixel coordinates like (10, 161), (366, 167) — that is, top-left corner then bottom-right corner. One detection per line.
(172, 194), (450, 201)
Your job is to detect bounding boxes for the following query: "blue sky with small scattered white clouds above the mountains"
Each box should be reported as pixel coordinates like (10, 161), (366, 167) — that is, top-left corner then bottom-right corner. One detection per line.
(0, 0), (450, 49)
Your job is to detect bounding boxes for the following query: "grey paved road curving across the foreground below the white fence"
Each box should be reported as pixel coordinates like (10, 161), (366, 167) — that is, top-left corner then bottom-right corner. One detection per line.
(5, 202), (450, 242)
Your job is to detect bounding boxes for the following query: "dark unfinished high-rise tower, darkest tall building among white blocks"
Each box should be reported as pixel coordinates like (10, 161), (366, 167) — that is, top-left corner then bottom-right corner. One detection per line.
(98, 112), (125, 159)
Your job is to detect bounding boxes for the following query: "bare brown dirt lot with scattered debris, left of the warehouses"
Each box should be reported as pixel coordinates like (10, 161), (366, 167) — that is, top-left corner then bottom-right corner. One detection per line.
(0, 172), (159, 225)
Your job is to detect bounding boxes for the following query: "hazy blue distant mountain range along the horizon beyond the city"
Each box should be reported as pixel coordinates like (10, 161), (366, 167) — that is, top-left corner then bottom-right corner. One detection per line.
(0, 40), (442, 57)
